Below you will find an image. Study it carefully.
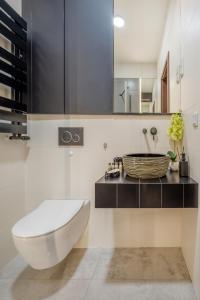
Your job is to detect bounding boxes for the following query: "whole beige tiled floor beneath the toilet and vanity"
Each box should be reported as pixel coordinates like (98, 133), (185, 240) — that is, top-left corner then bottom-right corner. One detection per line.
(0, 248), (196, 300)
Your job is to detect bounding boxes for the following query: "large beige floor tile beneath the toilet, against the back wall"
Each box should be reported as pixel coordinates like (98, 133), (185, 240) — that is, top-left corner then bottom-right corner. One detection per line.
(0, 249), (101, 280)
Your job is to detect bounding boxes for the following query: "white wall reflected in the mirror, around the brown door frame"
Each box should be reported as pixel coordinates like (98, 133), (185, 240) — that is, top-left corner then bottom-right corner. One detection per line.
(157, 0), (181, 112)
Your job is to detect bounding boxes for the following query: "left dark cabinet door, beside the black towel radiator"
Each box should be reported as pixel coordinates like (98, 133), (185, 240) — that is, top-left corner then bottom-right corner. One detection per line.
(22, 0), (64, 114)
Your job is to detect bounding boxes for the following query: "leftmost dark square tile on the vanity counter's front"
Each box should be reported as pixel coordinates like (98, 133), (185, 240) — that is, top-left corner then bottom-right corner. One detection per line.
(95, 184), (117, 208)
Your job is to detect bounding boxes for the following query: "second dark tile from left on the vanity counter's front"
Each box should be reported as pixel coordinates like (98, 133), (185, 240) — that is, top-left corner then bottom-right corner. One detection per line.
(117, 184), (139, 208)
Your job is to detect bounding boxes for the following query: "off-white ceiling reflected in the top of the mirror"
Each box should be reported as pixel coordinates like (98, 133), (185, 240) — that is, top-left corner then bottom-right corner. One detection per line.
(114, 0), (170, 63)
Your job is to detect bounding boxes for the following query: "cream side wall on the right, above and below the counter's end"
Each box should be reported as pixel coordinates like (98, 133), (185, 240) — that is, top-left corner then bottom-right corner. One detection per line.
(181, 0), (200, 299)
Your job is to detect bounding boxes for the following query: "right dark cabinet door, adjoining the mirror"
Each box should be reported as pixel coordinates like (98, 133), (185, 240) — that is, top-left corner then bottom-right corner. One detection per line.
(65, 0), (113, 115)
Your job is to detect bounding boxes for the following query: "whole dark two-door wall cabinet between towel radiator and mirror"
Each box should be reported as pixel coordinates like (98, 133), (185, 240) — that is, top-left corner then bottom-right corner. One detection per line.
(22, 0), (113, 115)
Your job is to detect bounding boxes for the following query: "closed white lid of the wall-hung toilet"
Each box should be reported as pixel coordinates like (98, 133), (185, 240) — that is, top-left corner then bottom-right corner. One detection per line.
(12, 200), (84, 238)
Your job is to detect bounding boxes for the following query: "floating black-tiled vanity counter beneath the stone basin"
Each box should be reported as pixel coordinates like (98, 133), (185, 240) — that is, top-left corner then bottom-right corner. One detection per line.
(95, 172), (198, 208)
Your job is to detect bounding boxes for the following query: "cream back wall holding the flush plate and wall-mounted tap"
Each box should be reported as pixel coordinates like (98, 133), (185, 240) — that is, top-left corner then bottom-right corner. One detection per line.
(27, 116), (181, 247)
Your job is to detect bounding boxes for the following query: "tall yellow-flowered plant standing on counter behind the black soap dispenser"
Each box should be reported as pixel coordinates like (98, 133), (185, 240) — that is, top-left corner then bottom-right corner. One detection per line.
(167, 113), (184, 171)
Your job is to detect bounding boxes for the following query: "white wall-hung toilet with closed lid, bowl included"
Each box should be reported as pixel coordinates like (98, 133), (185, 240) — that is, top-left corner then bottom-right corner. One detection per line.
(12, 200), (90, 269)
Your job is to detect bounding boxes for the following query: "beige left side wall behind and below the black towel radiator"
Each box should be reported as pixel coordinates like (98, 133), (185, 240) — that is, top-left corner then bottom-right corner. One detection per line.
(0, 0), (27, 267)
